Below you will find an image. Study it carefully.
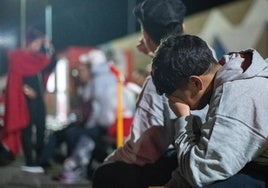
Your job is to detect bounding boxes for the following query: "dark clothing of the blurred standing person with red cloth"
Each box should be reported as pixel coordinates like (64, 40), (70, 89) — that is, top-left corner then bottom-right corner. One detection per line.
(21, 54), (56, 166)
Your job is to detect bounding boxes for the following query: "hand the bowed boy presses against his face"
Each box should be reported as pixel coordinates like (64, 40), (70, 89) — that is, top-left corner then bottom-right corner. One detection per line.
(168, 96), (190, 117)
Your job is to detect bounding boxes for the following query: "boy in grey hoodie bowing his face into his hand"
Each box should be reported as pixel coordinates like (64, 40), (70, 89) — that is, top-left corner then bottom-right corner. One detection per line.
(151, 35), (268, 188)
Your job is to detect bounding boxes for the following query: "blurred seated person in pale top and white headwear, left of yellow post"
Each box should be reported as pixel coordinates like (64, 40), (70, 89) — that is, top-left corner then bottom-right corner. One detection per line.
(53, 50), (134, 183)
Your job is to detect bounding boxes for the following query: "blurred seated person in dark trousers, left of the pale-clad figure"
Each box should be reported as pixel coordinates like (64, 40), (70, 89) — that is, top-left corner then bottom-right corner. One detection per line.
(39, 53), (92, 169)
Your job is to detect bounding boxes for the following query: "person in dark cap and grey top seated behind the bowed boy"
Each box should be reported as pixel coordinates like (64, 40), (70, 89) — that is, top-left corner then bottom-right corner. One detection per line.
(93, 0), (193, 188)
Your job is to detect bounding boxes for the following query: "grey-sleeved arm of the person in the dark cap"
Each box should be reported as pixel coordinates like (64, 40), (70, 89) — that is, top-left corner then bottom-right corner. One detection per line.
(103, 78), (175, 165)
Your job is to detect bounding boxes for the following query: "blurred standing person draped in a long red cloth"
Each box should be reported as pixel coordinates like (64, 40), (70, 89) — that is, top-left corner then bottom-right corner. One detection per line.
(2, 27), (56, 172)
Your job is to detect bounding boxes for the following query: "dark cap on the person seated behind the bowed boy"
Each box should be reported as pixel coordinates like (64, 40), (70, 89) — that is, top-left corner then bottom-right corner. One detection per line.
(133, 0), (186, 44)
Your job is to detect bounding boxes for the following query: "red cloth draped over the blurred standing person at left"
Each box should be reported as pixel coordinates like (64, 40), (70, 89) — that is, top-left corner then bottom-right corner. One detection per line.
(2, 49), (50, 155)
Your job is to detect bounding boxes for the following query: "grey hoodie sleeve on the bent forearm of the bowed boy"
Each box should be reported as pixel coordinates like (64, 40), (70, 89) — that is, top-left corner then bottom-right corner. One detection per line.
(176, 114), (262, 187)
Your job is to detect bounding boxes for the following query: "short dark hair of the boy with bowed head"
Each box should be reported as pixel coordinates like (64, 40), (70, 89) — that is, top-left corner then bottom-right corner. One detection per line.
(151, 35), (217, 95)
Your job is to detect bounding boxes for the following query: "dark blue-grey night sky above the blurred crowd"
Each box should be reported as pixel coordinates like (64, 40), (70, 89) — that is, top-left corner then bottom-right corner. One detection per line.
(0, 0), (239, 75)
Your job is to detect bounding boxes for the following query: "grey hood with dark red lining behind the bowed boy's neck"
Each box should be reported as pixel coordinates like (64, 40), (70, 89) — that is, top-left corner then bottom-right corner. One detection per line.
(214, 49), (268, 87)
